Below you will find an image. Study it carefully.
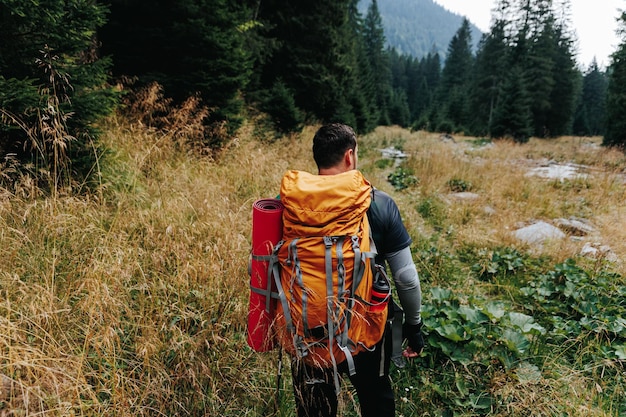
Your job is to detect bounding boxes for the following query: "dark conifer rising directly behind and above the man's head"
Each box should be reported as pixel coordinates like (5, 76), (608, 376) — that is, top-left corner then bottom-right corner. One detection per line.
(259, 0), (356, 125)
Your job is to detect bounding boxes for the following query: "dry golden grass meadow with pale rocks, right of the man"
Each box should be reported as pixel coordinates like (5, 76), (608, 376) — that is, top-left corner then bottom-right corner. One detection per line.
(356, 127), (626, 274)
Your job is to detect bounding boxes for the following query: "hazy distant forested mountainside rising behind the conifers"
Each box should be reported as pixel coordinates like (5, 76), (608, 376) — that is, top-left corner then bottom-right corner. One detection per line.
(359, 0), (482, 58)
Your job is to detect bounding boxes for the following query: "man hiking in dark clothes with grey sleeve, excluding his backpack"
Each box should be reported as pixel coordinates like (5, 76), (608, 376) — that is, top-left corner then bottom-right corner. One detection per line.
(291, 123), (424, 417)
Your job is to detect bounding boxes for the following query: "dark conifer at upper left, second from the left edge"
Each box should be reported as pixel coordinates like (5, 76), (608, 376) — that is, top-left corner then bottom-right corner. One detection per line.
(100, 0), (251, 131)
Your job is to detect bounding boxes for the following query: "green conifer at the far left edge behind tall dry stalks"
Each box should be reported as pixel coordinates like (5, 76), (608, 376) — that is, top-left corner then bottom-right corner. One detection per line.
(0, 0), (116, 181)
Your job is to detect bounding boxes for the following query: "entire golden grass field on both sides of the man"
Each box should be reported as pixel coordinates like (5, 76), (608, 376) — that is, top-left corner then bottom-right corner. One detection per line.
(0, 113), (626, 416)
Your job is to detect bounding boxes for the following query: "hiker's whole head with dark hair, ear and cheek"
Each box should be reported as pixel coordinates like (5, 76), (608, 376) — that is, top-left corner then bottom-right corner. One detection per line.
(313, 123), (357, 175)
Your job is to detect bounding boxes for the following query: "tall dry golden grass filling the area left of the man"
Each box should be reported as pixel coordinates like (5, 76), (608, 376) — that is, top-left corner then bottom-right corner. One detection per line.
(0, 96), (306, 416)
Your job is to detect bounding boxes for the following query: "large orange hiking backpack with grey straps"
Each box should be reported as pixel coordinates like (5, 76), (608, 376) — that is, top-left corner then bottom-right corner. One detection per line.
(270, 170), (390, 381)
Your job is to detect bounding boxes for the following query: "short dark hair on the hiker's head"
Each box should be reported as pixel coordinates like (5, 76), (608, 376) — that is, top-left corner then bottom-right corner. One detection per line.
(313, 123), (356, 169)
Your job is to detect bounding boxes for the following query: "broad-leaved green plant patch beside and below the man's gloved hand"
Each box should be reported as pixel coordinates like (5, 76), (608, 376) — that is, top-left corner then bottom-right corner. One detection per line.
(407, 287), (546, 415)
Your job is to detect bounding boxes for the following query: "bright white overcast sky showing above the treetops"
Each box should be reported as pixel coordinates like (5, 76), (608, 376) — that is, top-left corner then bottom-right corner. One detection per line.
(434, 0), (626, 69)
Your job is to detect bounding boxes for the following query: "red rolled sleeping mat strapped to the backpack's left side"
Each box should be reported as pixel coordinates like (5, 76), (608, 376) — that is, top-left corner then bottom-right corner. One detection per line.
(248, 198), (284, 352)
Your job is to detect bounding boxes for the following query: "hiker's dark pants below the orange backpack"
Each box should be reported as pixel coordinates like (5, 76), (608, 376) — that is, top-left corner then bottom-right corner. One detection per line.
(291, 332), (395, 417)
